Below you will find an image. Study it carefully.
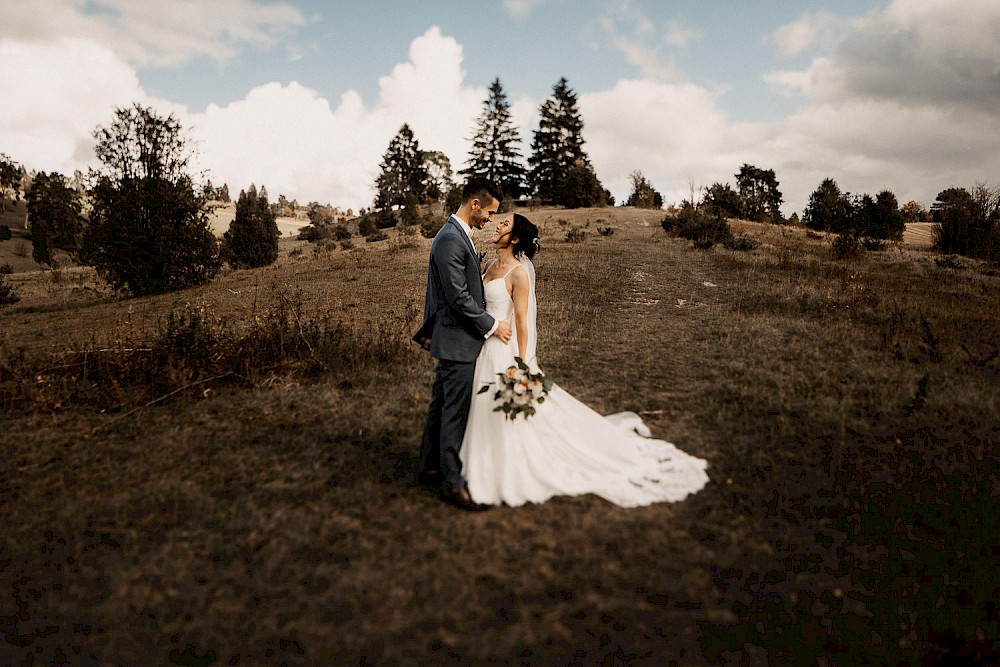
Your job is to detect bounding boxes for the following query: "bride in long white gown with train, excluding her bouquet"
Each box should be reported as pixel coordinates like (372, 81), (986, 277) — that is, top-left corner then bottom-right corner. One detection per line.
(460, 213), (708, 507)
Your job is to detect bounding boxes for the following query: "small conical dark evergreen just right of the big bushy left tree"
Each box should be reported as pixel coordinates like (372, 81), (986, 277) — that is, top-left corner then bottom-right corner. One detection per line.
(222, 183), (281, 268)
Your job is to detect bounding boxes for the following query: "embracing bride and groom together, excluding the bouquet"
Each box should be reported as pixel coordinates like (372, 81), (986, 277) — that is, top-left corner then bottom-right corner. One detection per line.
(414, 177), (708, 511)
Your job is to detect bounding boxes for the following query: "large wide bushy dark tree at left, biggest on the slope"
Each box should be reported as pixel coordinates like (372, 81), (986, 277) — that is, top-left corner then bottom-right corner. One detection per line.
(81, 104), (219, 295)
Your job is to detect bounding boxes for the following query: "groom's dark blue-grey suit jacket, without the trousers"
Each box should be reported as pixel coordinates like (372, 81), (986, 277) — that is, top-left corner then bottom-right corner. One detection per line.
(413, 216), (495, 361)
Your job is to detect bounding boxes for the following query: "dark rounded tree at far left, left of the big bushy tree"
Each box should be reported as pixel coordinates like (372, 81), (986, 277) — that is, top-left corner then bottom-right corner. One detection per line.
(27, 171), (82, 266)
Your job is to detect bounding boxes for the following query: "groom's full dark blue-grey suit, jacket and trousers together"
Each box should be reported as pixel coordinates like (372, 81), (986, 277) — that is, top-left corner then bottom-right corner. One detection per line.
(413, 216), (495, 488)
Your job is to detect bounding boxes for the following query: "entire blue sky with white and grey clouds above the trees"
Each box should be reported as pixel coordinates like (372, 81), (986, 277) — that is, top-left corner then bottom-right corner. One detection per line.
(0, 0), (1000, 215)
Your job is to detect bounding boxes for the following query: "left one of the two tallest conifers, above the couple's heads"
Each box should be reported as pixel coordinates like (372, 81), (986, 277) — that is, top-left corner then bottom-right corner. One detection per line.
(458, 78), (527, 199)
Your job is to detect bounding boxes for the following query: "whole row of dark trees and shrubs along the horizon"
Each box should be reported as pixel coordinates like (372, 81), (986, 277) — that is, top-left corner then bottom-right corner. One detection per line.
(0, 73), (1000, 294)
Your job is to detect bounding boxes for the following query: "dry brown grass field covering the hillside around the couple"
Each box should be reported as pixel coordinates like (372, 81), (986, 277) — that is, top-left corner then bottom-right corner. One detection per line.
(0, 208), (1000, 665)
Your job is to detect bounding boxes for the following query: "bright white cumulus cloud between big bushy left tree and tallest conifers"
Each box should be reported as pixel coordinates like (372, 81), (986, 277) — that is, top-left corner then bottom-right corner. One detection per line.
(186, 27), (486, 209)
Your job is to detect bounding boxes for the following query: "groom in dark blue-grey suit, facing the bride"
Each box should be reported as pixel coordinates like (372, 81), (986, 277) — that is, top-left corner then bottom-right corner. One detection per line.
(413, 176), (511, 510)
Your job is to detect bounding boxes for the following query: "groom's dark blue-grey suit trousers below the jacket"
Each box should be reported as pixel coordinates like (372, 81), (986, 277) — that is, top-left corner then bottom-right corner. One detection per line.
(420, 359), (476, 489)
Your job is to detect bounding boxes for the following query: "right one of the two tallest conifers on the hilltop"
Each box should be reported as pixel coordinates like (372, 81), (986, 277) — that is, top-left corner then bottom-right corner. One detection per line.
(528, 78), (605, 206)
